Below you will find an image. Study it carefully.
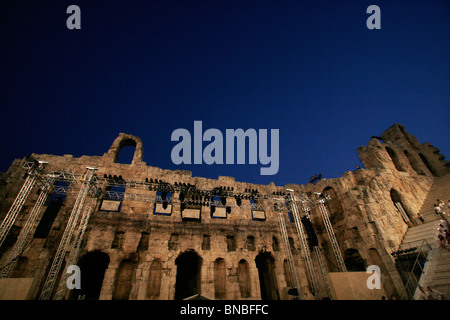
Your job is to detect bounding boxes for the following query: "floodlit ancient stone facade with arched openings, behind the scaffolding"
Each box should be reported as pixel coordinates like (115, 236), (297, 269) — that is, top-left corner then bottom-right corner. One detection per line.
(0, 124), (449, 300)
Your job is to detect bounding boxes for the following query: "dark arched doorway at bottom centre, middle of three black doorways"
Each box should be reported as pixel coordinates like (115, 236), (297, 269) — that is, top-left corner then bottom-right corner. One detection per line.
(175, 251), (202, 300)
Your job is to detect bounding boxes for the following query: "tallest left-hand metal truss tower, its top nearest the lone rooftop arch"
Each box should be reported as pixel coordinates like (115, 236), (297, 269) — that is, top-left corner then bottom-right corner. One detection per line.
(39, 167), (97, 300)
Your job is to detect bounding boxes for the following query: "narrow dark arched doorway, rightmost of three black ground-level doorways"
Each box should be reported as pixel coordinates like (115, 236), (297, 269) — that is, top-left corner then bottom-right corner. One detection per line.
(255, 252), (280, 300)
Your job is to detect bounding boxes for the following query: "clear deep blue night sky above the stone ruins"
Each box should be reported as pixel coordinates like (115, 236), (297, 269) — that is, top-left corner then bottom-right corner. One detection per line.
(0, 0), (450, 185)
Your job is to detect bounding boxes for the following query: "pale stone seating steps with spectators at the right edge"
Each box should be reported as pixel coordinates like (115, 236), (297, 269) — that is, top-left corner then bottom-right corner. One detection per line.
(399, 174), (450, 300)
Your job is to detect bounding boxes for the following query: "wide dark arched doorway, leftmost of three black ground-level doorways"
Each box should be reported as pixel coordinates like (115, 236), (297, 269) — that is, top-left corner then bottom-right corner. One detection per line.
(72, 251), (109, 300)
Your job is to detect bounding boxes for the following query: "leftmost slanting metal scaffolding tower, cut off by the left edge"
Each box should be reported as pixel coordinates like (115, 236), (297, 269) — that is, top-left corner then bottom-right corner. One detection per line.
(0, 161), (47, 247)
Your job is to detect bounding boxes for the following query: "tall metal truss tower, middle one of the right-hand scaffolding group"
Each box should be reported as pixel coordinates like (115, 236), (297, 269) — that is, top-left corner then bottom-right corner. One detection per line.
(287, 189), (320, 299)
